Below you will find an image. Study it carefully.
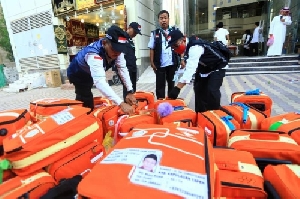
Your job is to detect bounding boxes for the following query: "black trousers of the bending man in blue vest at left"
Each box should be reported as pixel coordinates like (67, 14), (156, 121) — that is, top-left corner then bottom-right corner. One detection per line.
(68, 72), (94, 111)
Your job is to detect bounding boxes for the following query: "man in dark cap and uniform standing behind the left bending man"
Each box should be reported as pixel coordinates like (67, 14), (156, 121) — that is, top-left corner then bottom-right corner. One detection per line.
(123, 22), (142, 100)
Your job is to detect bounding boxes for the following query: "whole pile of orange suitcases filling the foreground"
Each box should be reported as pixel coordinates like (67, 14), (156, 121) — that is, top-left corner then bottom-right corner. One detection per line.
(0, 91), (300, 199)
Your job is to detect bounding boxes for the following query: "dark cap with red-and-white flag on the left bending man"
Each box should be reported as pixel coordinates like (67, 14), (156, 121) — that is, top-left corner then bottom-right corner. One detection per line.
(105, 25), (128, 53)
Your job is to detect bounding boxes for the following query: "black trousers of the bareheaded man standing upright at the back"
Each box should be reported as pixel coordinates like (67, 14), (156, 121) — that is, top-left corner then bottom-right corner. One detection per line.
(156, 65), (177, 99)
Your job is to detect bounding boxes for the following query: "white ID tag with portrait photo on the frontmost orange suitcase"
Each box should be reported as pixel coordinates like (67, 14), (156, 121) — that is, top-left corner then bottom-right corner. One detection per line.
(128, 154), (208, 199)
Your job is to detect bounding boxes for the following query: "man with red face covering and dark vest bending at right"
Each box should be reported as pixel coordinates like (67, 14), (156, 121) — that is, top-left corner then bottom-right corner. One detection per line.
(168, 30), (230, 112)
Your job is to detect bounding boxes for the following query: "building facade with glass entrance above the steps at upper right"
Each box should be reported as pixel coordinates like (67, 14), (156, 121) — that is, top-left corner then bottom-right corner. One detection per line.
(163, 0), (300, 55)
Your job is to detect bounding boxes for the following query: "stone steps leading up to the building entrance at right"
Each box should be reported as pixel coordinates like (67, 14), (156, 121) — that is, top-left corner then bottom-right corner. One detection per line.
(226, 55), (300, 75)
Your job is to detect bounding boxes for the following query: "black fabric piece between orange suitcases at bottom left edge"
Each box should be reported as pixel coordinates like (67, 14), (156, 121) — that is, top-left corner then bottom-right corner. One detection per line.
(40, 175), (82, 199)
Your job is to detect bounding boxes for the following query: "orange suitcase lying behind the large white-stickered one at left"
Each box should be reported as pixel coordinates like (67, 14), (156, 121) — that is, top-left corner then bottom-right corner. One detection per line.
(29, 98), (83, 122)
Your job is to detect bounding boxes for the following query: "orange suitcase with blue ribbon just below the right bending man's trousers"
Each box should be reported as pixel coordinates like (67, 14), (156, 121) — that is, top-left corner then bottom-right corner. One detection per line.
(197, 110), (240, 147)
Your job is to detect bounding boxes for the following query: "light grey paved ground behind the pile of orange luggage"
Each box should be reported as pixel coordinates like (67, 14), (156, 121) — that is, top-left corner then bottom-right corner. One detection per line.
(0, 68), (300, 115)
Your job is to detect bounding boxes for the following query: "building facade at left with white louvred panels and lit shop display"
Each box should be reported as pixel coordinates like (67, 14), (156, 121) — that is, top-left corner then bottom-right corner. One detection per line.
(1, 0), (161, 78)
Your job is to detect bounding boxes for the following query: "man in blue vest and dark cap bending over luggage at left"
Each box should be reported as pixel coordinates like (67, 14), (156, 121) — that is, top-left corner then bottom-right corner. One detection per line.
(67, 25), (136, 114)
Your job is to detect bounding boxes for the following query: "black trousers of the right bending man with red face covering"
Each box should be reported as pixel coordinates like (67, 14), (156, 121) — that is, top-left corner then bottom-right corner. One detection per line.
(194, 69), (226, 112)
